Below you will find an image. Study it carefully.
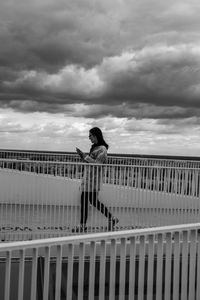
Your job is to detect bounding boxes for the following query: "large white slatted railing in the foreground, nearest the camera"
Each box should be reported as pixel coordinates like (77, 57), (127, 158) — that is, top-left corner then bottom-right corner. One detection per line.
(0, 223), (200, 300)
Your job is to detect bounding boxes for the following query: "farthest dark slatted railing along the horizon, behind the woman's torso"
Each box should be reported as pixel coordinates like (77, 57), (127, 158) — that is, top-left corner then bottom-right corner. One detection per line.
(0, 149), (200, 168)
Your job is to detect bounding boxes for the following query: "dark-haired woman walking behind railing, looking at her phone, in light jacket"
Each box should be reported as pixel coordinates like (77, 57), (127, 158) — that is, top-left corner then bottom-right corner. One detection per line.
(76, 127), (119, 232)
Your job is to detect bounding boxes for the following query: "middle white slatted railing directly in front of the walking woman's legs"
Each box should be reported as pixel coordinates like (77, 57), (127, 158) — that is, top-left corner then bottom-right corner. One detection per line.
(0, 160), (200, 240)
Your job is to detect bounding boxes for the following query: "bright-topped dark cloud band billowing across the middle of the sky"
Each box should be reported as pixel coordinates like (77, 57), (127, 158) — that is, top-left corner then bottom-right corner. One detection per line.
(0, 45), (200, 117)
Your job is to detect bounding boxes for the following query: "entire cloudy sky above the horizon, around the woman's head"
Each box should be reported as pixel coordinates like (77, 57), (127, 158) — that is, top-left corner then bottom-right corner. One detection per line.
(0, 0), (200, 156)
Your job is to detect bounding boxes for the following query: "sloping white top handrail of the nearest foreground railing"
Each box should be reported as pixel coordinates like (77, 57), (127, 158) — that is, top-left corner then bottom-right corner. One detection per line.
(0, 223), (200, 252)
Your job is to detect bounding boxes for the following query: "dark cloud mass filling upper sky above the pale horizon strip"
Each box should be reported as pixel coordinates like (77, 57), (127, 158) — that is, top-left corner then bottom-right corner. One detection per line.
(0, 0), (200, 119)
